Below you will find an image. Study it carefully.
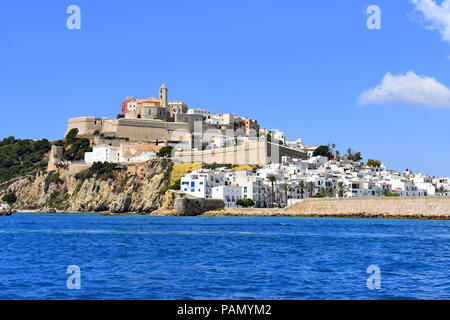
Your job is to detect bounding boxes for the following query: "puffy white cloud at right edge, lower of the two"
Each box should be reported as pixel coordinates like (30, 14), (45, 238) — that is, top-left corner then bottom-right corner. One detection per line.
(358, 71), (450, 109)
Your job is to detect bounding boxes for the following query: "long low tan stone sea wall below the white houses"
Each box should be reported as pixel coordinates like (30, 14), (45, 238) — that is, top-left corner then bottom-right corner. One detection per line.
(287, 197), (450, 217)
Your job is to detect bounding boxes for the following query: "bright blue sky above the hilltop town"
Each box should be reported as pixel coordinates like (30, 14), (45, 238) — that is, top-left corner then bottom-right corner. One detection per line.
(0, 0), (450, 176)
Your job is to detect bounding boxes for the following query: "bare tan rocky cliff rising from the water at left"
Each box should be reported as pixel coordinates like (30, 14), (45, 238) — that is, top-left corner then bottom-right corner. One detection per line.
(0, 159), (172, 213)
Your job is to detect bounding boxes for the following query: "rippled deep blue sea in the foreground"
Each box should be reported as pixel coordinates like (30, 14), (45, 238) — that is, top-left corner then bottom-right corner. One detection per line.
(0, 214), (450, 300)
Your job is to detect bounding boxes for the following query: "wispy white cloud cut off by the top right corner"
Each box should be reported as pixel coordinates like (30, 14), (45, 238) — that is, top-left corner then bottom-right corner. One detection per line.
(409, 0), (450, 43)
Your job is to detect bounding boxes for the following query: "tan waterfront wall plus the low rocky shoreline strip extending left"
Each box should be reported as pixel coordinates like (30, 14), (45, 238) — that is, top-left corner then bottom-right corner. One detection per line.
(204, 197), (450, 220)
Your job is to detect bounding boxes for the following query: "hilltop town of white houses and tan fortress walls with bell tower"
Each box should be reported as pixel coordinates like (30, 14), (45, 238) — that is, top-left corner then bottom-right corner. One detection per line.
(49, 85), (450, 208)
